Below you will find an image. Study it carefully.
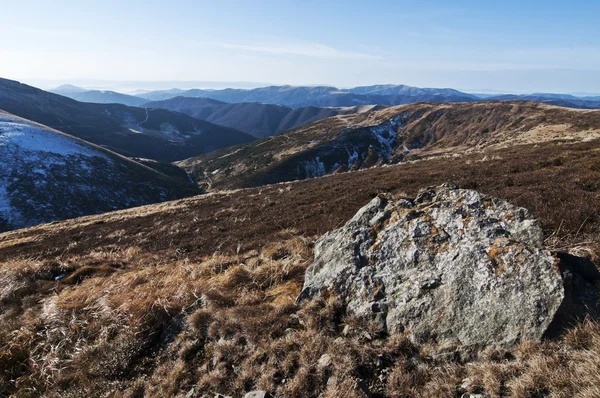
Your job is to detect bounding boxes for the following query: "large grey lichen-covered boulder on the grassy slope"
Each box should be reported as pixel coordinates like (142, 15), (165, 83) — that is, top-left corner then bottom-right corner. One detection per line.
(299, 185), (564, 348)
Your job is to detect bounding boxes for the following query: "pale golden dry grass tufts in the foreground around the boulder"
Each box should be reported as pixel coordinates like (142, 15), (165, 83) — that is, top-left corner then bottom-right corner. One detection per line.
(0, 231), (600, 397)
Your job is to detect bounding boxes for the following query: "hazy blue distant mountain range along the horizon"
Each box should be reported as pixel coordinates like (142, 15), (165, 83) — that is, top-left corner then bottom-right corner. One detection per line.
(52, 84), (600, 111)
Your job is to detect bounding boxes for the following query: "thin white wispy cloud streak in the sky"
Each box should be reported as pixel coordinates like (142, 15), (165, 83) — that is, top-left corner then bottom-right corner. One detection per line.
(214, 43), (382, 59)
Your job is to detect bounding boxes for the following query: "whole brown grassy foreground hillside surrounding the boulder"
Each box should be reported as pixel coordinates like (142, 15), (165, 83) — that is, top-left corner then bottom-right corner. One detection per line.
(0, 134), (600, 397)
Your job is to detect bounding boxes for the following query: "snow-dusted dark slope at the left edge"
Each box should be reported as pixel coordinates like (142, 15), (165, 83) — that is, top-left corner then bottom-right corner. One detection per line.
(0, 111), (198, 231)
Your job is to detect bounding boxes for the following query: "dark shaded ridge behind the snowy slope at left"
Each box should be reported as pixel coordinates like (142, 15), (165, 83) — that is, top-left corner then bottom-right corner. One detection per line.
(0, 79), (254, 161)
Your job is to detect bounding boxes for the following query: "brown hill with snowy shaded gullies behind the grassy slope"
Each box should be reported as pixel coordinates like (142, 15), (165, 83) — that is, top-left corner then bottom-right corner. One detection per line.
(178, 102), (600, 189)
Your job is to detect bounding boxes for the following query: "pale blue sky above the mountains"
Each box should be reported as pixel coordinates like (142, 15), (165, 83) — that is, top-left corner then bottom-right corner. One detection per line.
(0, 0), (600, 93)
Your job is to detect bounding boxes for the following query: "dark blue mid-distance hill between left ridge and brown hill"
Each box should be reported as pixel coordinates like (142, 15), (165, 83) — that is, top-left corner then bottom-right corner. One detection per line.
(146, 97), (380, 137)
